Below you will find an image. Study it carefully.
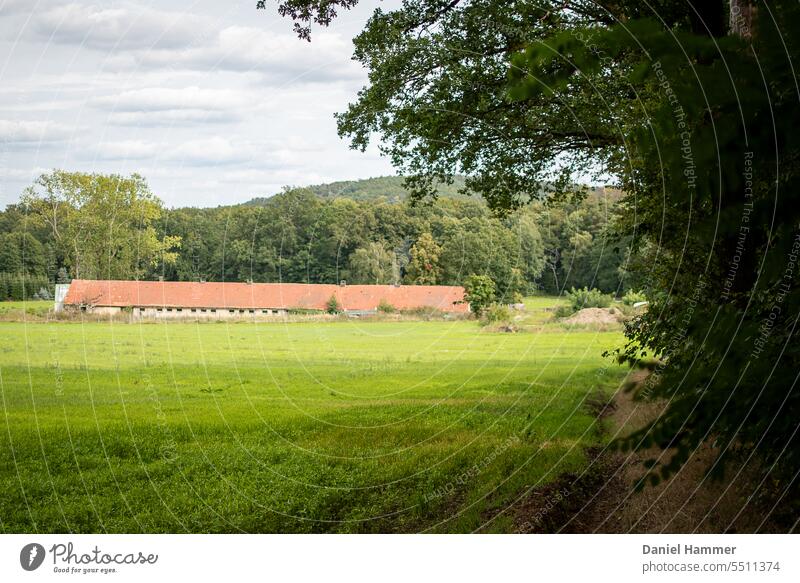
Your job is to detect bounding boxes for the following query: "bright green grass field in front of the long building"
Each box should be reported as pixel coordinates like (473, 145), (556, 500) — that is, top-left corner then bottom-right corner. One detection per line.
(0, 305), (624, 532)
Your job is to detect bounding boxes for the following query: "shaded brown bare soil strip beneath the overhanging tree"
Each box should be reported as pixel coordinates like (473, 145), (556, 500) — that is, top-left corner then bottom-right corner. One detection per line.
(514, 371), (792, 533)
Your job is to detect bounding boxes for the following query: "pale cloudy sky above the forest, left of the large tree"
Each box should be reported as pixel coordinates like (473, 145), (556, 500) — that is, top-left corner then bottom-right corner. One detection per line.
(0, 0), (395, 207)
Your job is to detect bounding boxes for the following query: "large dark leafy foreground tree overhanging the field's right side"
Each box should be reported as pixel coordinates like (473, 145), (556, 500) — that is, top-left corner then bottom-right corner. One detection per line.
(268, 0), (800, 499)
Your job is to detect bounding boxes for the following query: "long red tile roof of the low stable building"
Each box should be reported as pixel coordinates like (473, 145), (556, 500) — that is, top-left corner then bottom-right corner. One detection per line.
(64, 279), (469, 312)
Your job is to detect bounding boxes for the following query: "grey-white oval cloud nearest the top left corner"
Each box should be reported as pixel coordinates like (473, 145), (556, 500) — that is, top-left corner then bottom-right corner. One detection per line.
(34, 3), (208, 50)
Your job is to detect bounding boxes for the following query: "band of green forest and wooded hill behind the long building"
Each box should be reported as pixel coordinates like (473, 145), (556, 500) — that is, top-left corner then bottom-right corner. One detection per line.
(0, 171), (636, 302)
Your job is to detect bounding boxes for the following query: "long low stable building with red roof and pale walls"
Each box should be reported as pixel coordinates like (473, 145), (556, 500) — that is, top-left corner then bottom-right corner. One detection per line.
(56, 279), (469, 319)
